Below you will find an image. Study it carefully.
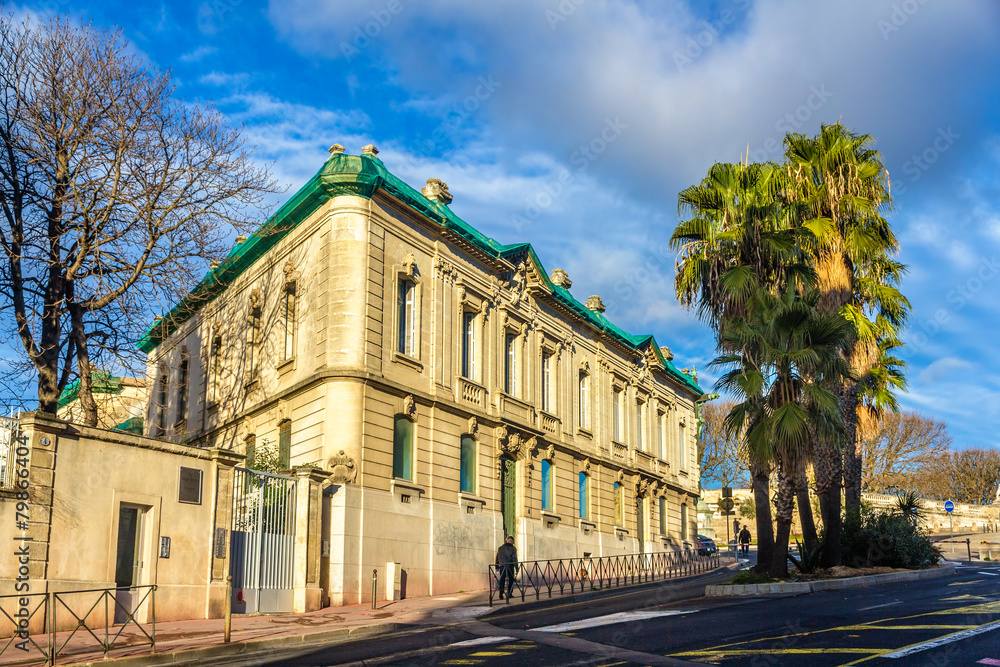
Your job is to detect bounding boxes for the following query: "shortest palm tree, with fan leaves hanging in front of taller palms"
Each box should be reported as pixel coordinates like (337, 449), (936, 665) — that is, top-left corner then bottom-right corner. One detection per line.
(713, 279), (850, 577)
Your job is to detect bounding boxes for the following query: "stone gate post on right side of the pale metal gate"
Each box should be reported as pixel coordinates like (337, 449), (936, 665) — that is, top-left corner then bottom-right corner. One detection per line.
(292, 466), (333, 613)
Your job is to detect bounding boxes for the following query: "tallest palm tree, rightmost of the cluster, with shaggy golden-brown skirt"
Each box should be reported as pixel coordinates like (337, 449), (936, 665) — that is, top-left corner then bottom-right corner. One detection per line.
(785, 123), (909, 566)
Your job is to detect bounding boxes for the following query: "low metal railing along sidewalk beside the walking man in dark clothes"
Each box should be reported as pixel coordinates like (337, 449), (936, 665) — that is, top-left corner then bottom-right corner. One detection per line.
(489, 549), (720, 607)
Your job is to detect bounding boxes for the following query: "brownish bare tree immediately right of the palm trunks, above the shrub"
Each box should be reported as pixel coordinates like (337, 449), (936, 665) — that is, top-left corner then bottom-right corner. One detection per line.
(862, 412), (951, 493)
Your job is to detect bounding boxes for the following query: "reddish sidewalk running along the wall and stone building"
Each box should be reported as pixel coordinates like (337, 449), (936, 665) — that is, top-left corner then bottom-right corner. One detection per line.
(0, 566), (725, 667)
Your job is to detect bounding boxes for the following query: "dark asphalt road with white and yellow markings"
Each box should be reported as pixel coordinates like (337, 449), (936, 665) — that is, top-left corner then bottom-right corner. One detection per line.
(236, 566), (1000, 667)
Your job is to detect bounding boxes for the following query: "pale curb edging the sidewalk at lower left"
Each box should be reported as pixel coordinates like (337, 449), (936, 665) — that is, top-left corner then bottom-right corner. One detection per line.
(72, 623), (412, 667)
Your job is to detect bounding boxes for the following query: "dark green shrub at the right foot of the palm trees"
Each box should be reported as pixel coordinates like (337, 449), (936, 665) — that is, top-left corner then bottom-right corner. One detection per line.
(841, 508), (941, 570)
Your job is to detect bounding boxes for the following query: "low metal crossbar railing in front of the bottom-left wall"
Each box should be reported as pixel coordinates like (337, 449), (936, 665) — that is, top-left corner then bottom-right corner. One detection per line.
(0, 585), (156, 665)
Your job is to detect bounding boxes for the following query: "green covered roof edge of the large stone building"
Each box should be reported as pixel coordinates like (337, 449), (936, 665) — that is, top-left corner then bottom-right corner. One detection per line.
(138, 154), (703, 395)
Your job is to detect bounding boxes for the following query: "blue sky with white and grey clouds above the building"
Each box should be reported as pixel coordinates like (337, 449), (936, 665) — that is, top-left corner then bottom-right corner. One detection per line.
(8, 0), (1000, 447)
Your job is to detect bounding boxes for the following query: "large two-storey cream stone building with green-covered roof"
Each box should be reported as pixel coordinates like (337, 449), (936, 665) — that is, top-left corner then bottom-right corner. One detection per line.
(140, 145), (703, 605)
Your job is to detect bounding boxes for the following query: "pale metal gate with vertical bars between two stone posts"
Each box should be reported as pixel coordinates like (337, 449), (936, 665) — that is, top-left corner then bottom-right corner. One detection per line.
(229, 468), (295, 613)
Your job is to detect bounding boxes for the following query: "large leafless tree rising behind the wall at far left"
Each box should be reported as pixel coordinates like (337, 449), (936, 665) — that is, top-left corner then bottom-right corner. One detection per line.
(0, 16), (275, 423)
